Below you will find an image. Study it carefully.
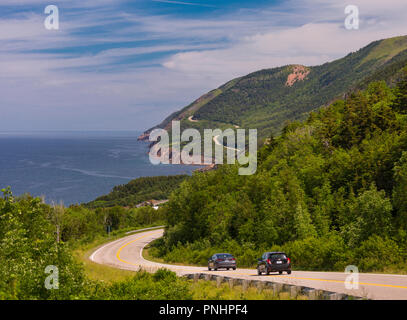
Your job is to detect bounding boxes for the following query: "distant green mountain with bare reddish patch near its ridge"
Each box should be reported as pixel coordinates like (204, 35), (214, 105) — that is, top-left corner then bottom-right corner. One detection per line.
(141, 36), (407, 139)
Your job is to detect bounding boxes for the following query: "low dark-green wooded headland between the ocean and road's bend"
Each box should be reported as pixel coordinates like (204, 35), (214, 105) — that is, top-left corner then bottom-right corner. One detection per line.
(86, 175), (188, 208)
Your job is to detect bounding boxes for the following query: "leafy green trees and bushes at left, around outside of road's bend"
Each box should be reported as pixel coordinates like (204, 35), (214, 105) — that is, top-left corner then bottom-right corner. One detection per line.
(0, 189), (169, 300)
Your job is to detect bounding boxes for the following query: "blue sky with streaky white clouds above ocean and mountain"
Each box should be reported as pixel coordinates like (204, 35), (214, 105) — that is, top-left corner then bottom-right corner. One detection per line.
(0, 0), (407, 131)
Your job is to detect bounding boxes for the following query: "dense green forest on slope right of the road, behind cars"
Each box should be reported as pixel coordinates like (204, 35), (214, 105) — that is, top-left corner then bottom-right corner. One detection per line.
(151, 68), (407, 272)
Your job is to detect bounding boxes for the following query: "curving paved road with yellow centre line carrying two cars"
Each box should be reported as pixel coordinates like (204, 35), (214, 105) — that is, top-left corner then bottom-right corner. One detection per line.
(90, 229), (407, 300)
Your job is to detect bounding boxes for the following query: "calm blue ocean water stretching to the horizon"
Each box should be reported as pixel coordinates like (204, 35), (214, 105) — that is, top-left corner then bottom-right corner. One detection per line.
(0, 132), (201, 205)
